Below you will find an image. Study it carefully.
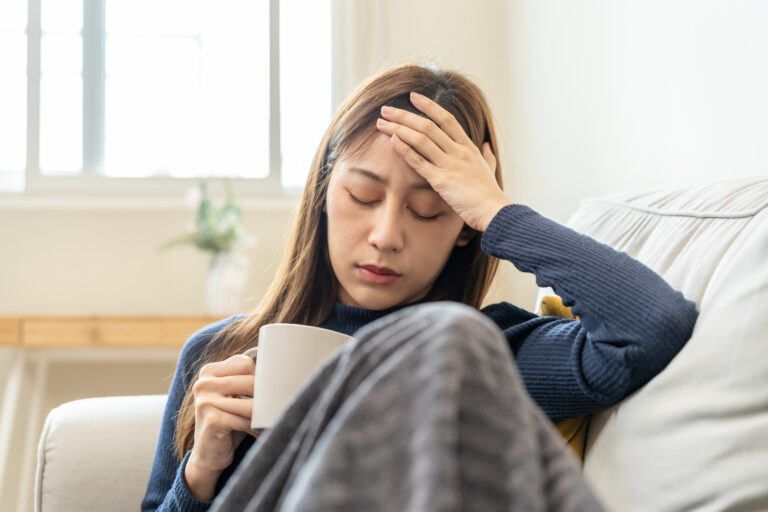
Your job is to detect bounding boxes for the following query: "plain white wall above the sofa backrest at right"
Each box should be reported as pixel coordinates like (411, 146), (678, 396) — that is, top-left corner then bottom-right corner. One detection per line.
(505, 0), (768, 221)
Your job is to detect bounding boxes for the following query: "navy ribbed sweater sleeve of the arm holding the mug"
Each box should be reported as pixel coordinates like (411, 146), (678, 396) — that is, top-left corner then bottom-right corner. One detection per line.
(141, 316), (243, 512)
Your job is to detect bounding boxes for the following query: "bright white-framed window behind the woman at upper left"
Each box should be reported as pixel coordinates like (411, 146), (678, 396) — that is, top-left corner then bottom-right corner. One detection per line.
(0, 0), (331, 193)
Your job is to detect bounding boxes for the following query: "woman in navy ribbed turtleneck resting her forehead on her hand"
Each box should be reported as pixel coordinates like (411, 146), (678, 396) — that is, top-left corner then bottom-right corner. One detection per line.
(142, 66), (697, 510)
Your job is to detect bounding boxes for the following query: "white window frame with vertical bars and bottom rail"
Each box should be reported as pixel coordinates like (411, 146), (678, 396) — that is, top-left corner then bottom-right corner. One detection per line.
(18, 0), (300, 199)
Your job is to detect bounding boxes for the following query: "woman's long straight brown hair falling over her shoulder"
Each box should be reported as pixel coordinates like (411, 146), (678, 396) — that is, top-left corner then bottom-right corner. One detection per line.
(175, 65), (502, 460)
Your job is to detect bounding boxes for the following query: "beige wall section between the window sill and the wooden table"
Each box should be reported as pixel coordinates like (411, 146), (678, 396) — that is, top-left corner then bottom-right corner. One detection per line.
(0, 201), (293, 314)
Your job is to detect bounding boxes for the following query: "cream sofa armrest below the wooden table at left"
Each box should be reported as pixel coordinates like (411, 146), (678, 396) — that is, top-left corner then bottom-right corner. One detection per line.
(35, 395), (167, 512)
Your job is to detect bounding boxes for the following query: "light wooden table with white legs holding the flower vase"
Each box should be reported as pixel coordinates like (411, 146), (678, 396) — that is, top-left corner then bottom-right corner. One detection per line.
(0, 315), (221, 508)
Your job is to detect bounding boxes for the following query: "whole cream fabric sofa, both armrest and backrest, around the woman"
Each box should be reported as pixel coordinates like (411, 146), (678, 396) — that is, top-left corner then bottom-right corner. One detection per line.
(35, 177), (768, 512)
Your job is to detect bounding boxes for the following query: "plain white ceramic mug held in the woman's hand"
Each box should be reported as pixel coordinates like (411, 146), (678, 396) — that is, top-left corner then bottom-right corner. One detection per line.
(246, 324), (350, 431)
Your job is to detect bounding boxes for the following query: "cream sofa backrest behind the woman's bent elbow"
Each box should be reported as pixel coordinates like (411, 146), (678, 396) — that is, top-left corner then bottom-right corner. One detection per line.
(540, 177), (768, 512)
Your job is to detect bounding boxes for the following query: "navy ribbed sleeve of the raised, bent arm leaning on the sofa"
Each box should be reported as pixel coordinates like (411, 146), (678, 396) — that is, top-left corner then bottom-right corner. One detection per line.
(482, 204), (698, 421)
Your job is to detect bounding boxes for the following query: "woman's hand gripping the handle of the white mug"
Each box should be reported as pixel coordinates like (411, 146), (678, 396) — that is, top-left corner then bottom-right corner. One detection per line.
(184, 354), (258, 501)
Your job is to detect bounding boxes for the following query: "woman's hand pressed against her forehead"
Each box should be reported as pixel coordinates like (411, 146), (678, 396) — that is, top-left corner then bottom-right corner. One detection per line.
(376, 92), (511, 231)
